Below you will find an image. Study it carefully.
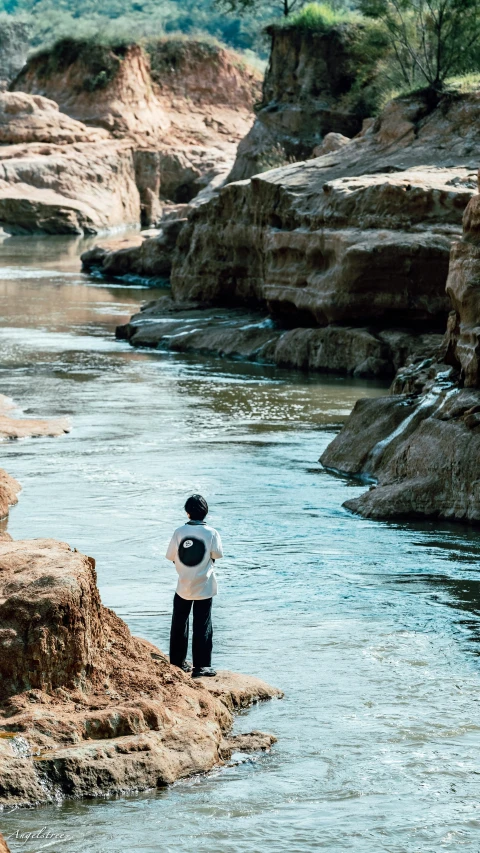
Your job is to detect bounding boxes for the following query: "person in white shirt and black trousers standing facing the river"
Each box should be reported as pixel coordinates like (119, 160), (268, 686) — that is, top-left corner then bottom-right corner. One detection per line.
(166, 495), (223, 678)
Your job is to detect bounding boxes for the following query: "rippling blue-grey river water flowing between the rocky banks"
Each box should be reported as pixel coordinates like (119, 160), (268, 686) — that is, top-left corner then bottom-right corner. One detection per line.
(0, 233), (480, 853)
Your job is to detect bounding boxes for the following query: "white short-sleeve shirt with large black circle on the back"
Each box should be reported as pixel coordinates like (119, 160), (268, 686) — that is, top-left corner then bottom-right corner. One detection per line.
(165, 521), (223, 601)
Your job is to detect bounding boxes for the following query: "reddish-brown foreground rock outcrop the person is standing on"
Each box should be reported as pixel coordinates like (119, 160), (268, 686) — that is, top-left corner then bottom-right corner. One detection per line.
(0, 540), (281, 806)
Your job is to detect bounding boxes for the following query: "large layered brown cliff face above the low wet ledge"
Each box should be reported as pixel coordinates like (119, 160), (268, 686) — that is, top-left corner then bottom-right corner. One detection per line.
(172, 165), (474, 328)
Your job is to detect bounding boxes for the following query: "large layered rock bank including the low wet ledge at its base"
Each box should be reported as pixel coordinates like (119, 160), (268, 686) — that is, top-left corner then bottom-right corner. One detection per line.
(110, 90), (478, 377)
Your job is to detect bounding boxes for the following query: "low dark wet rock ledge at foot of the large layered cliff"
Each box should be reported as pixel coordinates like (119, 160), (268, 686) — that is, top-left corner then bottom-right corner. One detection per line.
(115, 292), (442, 379)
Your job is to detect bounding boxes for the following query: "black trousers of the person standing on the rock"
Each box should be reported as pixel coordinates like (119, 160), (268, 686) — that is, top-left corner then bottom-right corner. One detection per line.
(170, 593), (213, 669)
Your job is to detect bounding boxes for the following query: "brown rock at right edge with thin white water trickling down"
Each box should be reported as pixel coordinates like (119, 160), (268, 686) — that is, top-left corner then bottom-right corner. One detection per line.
(321, 168), (480, 524)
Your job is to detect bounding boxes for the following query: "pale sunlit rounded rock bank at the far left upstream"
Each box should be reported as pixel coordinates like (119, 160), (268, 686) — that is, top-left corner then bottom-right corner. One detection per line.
(0, 92), (140, 234)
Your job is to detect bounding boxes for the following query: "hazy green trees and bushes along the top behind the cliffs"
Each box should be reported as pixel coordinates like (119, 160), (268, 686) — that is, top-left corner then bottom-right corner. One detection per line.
(0, 0), (480, 108)
